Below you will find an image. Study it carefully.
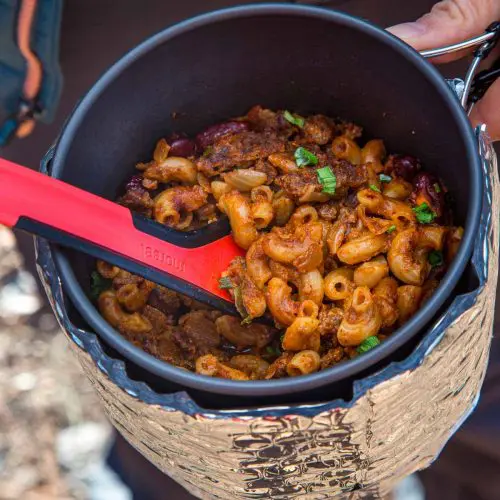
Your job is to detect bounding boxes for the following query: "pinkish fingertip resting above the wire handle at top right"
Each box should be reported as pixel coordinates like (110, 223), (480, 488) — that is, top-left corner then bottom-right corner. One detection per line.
(388, 0), (500, 62)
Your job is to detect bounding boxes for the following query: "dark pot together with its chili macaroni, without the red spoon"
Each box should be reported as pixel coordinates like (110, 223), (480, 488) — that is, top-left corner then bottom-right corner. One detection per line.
(47, 5), (482, 406)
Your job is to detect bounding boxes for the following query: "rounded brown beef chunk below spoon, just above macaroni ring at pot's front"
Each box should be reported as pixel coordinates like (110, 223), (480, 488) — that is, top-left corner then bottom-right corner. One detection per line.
(173, 311), (221, 359)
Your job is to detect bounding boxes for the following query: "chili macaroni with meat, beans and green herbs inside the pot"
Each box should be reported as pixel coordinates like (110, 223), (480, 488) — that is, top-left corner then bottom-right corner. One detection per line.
(96, 106), (463, 380)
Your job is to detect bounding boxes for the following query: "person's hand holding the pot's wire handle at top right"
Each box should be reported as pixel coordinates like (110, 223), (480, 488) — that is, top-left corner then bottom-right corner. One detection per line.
(388, 0), (500, 140)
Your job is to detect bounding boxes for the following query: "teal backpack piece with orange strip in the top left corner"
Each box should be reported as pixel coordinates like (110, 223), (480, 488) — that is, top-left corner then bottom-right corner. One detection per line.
(0, 0), (62, 148)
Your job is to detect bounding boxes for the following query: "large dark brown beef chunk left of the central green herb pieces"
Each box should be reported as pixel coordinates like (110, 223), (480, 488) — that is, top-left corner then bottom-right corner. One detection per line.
(197, 131), (285, 177)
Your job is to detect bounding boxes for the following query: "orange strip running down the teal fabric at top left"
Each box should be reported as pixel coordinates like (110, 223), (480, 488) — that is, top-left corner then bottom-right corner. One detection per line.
(17, 0), (43, 137)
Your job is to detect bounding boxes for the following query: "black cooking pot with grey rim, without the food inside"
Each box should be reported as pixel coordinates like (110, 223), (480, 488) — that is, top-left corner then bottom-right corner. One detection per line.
(47, 5), (482, 407)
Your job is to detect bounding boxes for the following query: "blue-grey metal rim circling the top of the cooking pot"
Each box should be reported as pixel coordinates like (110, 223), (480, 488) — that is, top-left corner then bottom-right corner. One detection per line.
(50, 3), (483, 397)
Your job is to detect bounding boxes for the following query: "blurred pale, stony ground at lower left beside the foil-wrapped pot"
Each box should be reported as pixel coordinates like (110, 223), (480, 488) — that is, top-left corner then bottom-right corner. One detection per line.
(0, 226), (130, 500)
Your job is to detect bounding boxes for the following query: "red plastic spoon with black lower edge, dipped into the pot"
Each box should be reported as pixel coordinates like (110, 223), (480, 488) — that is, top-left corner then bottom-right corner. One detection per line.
(0, 158), (242, 307)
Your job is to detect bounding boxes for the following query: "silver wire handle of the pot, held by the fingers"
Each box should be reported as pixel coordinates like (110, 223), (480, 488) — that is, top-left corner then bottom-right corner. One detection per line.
(420, 21), (500, 114)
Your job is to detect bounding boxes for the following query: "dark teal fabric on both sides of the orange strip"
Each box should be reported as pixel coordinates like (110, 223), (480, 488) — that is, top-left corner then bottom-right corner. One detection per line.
(0, 0), (63, 145)
